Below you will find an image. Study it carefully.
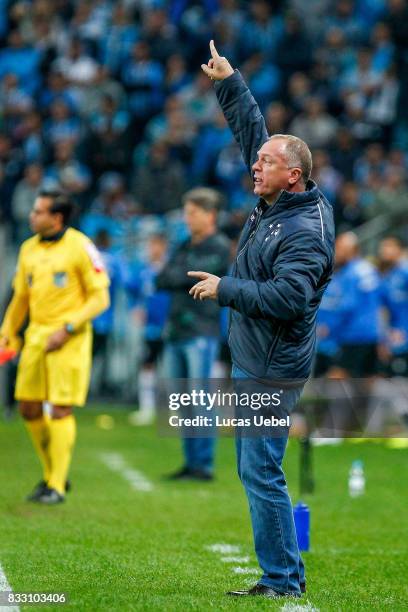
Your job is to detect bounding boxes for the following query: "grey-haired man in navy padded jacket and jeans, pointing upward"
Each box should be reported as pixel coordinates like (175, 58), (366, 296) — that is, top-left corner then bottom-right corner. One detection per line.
(190, 41), (334, 598)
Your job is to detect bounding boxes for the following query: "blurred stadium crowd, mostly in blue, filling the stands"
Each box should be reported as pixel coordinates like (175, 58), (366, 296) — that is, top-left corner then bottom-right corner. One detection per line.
(0, 0), (408, 414)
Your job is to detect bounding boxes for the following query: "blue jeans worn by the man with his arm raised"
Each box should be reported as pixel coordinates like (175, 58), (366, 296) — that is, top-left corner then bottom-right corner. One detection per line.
(232, 365), (305, 594)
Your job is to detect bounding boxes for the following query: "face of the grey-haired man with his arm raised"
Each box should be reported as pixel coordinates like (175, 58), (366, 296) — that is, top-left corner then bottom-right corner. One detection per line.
(252, 138), (300, 201)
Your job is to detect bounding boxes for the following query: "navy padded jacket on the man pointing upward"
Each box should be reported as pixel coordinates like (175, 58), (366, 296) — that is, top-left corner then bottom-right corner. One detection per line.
(216, 71), (334, 384)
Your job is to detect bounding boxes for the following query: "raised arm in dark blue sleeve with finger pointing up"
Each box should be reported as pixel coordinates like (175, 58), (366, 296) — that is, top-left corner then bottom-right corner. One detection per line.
(201, 41), (268, 176)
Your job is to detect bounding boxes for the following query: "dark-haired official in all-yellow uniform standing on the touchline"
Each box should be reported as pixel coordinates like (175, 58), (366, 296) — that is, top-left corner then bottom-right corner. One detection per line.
(0, 191), (109, 504)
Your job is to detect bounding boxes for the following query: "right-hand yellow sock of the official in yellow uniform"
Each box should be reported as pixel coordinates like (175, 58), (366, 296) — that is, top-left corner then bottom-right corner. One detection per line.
(48, 414), (76, 495)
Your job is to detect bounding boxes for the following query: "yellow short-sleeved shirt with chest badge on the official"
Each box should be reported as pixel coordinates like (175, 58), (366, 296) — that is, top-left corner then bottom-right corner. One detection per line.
(13, 228), (109, 327)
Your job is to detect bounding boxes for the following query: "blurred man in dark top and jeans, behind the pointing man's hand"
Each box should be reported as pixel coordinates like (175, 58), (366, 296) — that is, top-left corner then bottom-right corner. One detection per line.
(156, 187), (230, 480)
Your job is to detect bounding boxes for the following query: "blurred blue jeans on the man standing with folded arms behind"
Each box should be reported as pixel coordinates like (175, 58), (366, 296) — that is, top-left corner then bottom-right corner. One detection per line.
(163, 336), (218, 474)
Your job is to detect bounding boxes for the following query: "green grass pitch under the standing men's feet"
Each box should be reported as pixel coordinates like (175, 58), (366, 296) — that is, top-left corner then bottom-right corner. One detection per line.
(0, 406), (408, 612)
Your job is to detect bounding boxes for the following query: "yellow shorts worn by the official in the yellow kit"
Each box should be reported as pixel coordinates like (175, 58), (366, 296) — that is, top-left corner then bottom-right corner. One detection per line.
(15, 323), (92, 406)
